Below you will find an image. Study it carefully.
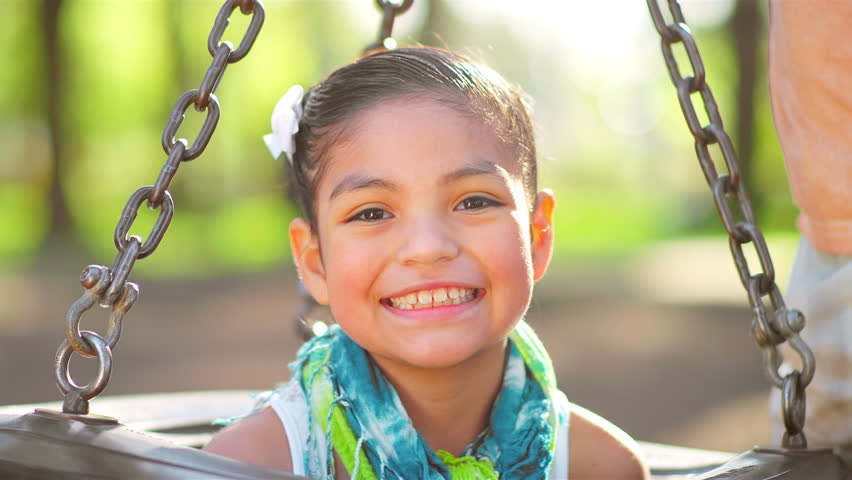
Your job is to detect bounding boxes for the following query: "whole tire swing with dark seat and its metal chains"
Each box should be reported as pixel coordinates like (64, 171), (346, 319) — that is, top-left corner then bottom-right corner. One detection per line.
(0, 0), (850, 480)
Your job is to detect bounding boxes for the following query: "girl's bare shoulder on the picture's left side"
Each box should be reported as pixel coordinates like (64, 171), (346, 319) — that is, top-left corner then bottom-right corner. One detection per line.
(204, 407), (293, 472)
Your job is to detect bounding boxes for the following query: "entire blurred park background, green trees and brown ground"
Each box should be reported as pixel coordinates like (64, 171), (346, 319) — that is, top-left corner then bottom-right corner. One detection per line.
(0, 0), (797, 451)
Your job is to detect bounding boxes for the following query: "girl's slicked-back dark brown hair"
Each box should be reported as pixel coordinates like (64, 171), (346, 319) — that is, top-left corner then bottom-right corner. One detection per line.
(286, 47), (537, 231)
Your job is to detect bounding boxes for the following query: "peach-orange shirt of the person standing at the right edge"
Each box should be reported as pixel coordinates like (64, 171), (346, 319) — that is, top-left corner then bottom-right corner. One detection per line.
(769, 0), (852, 255)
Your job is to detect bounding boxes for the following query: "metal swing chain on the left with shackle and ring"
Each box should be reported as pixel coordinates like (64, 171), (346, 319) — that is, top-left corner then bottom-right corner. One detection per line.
(55, 0), (265, 415)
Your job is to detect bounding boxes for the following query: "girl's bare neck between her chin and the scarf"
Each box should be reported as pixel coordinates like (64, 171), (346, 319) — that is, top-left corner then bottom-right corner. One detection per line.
(373, 341), (506, 456)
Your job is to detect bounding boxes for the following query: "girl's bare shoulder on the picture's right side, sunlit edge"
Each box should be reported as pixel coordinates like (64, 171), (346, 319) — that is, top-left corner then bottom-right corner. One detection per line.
(568, 404), (650, 480)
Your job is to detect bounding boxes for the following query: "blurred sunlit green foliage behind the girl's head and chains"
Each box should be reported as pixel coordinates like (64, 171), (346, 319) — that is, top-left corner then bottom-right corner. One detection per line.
(0, 0), (795, 276)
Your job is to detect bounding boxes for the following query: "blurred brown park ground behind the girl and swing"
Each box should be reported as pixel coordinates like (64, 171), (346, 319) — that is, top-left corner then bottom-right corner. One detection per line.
(0, 238), (793, 452)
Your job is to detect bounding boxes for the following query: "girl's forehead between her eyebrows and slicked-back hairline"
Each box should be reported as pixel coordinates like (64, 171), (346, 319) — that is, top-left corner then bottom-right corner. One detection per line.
(317, 96), (522, 199)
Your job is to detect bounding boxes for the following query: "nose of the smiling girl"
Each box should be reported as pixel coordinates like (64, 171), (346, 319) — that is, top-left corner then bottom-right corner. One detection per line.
(397, 214), (461, 266)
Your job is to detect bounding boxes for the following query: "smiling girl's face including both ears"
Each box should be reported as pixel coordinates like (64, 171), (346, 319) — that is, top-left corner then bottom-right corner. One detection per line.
(290, 98), (553, 368)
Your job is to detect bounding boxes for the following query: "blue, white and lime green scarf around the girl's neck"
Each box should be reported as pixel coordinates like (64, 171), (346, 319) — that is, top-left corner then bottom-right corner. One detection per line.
(290, 322), (565, 480)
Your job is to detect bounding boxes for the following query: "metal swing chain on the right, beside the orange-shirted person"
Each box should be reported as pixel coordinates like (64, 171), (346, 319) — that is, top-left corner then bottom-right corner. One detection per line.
(647, 0), (815, 448)
